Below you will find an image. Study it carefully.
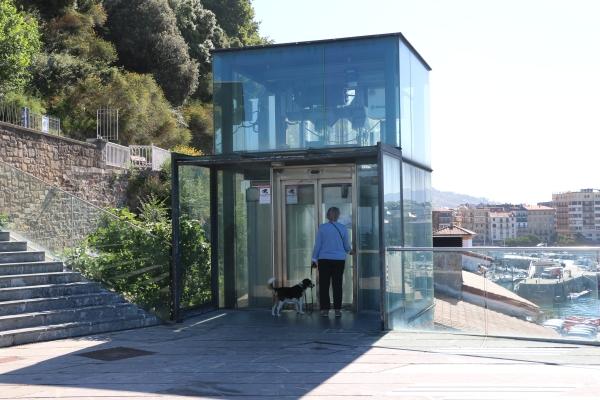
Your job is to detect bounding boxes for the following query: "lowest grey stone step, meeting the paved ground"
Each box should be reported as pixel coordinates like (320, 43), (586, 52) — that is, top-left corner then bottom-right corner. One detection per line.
(0, 314), (160, 347)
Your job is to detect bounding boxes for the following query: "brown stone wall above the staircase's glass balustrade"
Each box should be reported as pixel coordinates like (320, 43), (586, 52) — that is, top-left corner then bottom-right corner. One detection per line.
(0, 123), (128, 207)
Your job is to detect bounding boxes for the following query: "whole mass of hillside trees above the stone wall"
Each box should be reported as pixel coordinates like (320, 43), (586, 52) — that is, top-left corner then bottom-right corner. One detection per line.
(0, 0), (266, 148)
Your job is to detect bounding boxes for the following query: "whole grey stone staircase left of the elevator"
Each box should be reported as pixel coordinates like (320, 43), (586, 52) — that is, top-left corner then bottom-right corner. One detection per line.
(0, 231), (160, 347)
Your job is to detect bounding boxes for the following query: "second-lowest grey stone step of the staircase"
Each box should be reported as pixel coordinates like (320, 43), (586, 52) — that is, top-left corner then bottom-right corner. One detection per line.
(0, 303), (140, 331)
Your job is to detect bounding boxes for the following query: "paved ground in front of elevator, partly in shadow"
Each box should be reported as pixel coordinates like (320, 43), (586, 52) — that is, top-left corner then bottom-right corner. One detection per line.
(0, 311), (600, 400)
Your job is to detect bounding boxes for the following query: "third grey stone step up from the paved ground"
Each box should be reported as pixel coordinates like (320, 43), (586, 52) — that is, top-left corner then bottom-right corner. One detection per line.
(0, 291), (123, 316)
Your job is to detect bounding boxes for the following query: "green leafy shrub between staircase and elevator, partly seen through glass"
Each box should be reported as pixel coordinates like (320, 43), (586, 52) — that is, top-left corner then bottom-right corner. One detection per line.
(67, 199), (211, 318)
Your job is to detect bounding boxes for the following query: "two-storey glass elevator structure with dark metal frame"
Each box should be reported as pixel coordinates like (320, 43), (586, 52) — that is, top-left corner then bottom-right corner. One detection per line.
(171, 33), (433, 329)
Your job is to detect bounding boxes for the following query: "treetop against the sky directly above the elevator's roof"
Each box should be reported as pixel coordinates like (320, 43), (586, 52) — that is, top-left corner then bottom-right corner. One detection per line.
(202, 0), (268, 47)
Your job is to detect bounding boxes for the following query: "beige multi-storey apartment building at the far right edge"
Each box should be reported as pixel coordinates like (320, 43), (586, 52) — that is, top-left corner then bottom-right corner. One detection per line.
(552, 189), (600, 241)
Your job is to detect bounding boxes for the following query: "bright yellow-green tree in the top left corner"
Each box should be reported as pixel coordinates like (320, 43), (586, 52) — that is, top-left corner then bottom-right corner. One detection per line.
(0, 0), (41, 95)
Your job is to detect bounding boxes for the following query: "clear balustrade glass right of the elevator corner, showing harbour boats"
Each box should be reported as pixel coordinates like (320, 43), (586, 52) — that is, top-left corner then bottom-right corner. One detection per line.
(428, 247), (600, 341)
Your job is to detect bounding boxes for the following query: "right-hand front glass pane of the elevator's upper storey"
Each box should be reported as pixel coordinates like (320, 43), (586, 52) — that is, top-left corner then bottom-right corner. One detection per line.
(323, 38), (398, 146)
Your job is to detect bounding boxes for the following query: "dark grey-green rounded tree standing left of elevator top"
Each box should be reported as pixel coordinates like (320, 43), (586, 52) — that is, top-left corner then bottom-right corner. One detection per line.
(105, 0), (198, 105)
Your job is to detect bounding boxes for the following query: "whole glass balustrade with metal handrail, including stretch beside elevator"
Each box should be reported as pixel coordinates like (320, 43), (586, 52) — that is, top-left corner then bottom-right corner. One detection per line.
(384, 247), (600, 342)
